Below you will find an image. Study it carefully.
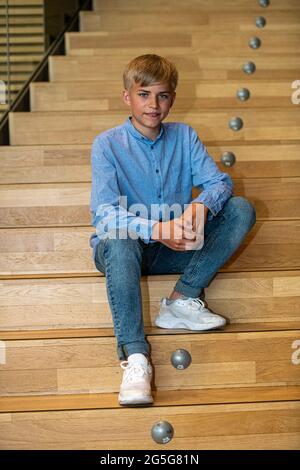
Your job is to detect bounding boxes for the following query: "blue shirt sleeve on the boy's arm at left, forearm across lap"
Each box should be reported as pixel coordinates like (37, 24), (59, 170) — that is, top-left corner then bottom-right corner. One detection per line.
(90, 138), (157, 243)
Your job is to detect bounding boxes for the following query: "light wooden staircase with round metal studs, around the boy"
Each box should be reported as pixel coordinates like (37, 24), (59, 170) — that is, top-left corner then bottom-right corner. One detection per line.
(0, 0), (300, 450)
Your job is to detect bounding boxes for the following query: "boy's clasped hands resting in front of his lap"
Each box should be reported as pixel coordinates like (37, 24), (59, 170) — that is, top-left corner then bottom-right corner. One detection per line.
(151, 217), (199, 251)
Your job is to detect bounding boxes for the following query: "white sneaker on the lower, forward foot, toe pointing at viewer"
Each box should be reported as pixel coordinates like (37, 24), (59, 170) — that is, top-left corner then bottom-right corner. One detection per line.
(119, 353), (153, 405)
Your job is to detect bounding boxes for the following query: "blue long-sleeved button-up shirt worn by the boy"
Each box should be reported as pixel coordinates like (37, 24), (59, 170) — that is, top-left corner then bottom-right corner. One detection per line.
(90, 117), (233, 256)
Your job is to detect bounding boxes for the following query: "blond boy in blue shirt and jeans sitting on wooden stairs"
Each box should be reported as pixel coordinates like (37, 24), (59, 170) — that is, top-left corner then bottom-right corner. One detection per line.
(90, 54), (256, 405)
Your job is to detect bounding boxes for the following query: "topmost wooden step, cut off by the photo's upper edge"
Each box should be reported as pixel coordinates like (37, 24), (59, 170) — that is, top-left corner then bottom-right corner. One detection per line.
(93, 0), (300, 14)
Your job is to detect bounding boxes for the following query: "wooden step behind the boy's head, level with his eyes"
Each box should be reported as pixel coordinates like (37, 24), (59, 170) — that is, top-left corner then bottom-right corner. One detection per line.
(29, 80), (292, 112)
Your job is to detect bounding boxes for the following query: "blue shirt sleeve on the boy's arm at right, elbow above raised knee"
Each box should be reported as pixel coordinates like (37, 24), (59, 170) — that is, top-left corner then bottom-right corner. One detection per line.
(190, 127), (233, 220)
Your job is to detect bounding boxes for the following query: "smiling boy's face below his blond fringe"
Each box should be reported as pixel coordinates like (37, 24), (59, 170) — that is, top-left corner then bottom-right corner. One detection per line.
(123, 83), (176, 139)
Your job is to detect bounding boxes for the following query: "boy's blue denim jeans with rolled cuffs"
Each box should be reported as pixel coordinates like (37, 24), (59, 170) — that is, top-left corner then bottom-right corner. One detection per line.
(95, 196), (256, 360)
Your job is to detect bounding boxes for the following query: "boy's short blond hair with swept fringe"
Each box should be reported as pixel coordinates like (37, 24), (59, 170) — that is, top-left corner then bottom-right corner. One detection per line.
(123, 54), (178, 91)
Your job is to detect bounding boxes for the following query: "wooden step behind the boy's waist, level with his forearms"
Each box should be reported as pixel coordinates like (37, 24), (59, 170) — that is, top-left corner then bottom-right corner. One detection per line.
(0, 177), (300, 228)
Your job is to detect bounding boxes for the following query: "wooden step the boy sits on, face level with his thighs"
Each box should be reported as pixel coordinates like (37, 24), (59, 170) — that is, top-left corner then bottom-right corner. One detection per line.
(0, 220), (300, 279)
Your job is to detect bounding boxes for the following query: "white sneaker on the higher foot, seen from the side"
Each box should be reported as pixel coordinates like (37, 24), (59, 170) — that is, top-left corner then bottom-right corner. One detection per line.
(155, 297), (226, 331)
